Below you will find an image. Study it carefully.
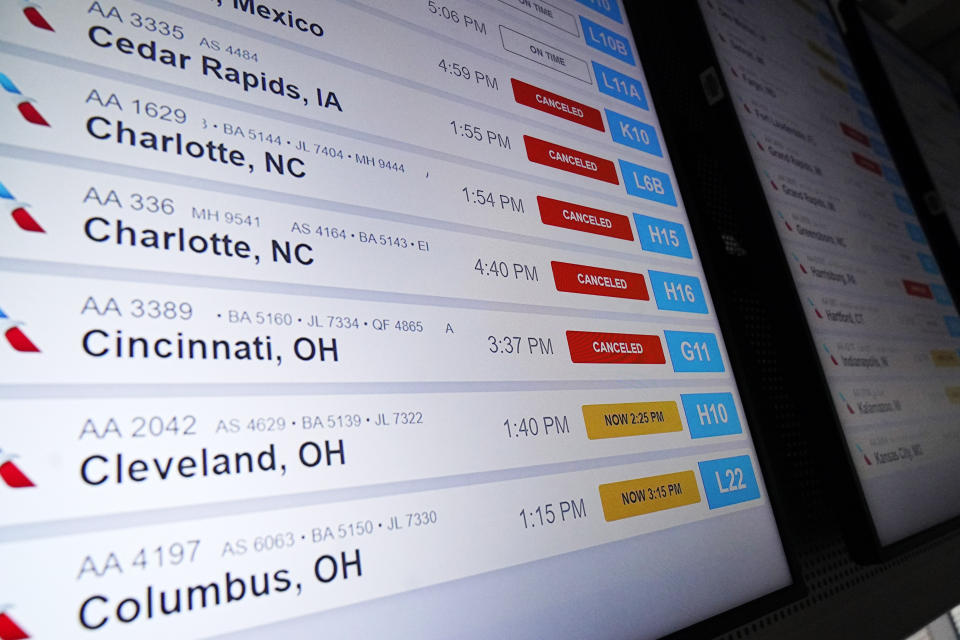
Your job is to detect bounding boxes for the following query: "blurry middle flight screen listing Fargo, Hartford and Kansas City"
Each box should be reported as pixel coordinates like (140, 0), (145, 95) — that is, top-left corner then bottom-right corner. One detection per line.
(700, 0), (960, 545)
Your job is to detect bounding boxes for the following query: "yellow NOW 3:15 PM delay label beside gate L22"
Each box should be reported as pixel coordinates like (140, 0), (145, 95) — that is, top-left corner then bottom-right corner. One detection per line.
(599, 471), (700, 522)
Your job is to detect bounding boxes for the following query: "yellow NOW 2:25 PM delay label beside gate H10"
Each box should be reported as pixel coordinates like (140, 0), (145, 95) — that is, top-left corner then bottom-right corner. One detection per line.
(583, 400), (683, 440)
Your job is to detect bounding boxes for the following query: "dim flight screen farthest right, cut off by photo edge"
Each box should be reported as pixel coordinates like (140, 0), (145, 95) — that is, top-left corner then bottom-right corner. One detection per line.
(860, 12), (960, 248)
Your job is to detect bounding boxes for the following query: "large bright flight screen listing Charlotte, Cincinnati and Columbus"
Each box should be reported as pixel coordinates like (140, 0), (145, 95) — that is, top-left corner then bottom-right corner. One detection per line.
(0, 0), (791, 638)
